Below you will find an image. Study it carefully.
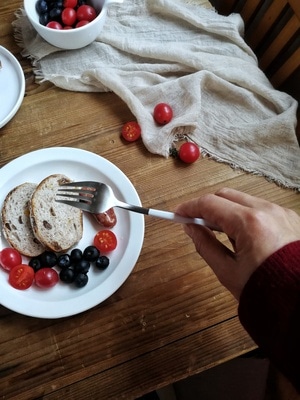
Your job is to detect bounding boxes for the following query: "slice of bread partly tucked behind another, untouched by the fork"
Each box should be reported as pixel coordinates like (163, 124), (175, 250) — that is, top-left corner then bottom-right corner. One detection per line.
(1, 182), (45, 257)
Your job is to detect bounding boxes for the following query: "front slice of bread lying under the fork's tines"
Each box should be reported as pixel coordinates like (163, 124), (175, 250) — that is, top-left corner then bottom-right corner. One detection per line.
(30, 174), (83, 253)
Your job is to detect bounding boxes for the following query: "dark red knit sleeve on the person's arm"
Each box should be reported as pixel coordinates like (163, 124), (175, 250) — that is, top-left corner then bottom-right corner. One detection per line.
(239, 240), (300, 392)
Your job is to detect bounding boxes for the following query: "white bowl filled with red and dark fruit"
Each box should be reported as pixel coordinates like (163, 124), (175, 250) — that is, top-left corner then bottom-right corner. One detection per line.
(24, 0), (123, 50)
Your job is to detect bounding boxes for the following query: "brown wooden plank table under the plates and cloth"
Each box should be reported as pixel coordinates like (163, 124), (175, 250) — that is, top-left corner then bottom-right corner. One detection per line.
(0, 0), (300, 400)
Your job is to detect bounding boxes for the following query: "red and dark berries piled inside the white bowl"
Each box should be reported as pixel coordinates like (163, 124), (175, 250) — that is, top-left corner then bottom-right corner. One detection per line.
(36, 0), (97, 29)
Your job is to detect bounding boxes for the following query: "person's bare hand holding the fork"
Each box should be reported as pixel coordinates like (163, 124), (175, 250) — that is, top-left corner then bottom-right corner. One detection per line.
(176, 188), (300, 300)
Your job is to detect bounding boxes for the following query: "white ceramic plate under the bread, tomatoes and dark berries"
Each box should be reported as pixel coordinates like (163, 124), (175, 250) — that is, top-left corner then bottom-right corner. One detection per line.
(0, 147), (144, 318)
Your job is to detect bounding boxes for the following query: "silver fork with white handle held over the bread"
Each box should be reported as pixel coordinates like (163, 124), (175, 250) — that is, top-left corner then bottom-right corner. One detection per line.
(56, 181), (220, 231)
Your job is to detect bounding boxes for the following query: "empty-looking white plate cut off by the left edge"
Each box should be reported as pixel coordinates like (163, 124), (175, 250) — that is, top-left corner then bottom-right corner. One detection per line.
(0, 46), (25, 128)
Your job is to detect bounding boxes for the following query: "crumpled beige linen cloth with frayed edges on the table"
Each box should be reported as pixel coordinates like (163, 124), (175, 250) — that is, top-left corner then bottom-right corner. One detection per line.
(14, 0), (300, 191)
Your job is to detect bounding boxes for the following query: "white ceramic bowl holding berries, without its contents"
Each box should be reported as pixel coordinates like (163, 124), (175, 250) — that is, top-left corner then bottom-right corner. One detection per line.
(24, 0), (123, 50)
